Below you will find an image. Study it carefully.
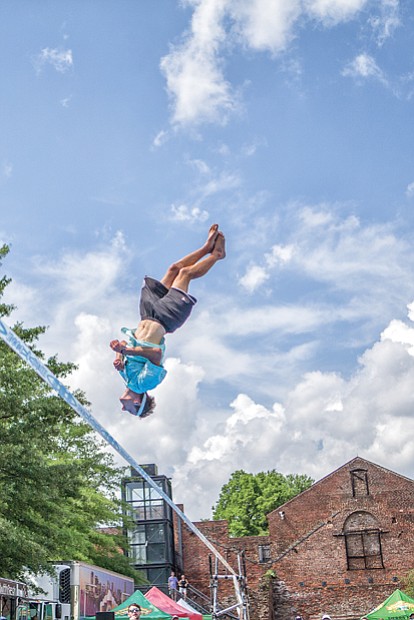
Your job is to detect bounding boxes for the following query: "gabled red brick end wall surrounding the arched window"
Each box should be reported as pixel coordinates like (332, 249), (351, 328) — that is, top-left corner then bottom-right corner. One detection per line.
(268, 458), (414, 618)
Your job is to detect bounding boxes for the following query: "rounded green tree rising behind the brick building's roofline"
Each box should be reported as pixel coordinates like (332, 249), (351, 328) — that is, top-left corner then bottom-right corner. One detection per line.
(213, 469), (313, 536)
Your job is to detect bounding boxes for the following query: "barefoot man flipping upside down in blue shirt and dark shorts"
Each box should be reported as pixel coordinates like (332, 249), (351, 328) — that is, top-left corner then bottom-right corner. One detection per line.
(110, 224), (226, 417)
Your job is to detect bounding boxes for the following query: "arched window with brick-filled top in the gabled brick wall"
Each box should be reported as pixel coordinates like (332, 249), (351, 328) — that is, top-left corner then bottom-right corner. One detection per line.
(343, 511), (384, 570)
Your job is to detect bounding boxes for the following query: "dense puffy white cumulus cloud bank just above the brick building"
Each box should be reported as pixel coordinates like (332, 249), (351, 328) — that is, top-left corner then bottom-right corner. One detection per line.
(173, 302), (414, 518)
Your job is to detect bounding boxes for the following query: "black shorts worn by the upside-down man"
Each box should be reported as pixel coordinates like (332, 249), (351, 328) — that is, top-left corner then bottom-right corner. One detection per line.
(139, 276), (197, 334)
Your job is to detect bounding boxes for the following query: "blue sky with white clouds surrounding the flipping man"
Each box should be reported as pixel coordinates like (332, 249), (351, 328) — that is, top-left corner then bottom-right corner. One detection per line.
(0, 0), (414, 520)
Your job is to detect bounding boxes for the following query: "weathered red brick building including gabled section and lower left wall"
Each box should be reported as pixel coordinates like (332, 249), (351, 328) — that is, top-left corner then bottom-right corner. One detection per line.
(180, 457), (414, 620)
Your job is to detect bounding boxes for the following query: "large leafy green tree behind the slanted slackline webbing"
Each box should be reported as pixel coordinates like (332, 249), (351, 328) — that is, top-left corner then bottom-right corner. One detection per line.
(0, 246), (136, 579)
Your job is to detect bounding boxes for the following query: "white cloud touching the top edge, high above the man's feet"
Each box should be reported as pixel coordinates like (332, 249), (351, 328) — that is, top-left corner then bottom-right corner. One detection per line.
(160, 0), (368, 126)
